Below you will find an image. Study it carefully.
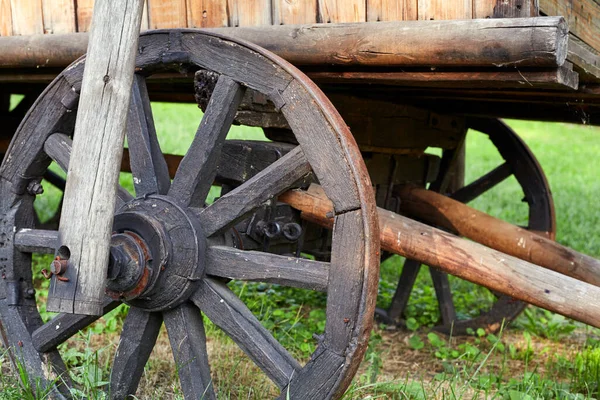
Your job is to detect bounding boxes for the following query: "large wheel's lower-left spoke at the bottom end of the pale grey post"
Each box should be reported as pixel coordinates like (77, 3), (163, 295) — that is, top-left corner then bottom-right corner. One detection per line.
(32, 298), (121, 353)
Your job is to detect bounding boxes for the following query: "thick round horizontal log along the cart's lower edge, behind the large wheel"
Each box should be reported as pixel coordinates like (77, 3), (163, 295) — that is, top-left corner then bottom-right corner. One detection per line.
(0, 17), (568, 68)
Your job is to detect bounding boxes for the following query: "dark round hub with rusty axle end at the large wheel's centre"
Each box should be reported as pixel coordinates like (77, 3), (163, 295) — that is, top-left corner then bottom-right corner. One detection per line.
(106, 195), (206, 311)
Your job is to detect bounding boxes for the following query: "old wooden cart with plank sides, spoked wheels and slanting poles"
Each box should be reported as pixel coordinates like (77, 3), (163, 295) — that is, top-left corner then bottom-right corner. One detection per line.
(0, 0), (600, 399)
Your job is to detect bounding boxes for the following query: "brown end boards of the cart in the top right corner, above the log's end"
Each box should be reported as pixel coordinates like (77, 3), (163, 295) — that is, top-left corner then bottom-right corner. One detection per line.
(540, 0), (600, 55)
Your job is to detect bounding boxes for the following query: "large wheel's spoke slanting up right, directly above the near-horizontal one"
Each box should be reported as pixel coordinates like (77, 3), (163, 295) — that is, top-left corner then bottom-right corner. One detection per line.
(199, 147), (311, 236)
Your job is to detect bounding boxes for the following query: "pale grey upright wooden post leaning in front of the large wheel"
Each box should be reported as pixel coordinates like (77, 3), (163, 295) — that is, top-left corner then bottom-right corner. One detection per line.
(47, 0), (144, 315)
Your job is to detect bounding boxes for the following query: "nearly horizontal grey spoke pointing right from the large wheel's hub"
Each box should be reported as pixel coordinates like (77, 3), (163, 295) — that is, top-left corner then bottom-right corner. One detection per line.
(206, 246), (329, 292)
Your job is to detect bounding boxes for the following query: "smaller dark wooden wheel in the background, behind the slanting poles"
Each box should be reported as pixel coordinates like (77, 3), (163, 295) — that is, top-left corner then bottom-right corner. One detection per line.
(377, 118), (556, 335)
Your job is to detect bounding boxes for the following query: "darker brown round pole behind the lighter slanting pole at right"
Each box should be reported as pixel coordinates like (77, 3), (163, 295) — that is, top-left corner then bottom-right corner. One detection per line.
(398, 185), (600, 286)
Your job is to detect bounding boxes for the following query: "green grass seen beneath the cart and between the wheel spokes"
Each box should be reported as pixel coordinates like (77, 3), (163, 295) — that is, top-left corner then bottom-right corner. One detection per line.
(0, 95), (600, 400)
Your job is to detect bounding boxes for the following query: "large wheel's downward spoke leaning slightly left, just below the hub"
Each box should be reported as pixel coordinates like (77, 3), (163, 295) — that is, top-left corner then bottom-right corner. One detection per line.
(110, 307), (162, 400)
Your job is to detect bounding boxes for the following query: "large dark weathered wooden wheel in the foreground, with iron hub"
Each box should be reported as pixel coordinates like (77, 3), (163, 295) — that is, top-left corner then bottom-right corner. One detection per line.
(0, 30), (379, 399)
